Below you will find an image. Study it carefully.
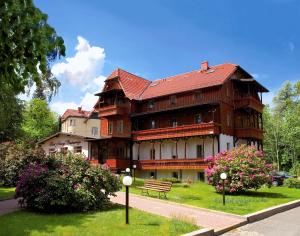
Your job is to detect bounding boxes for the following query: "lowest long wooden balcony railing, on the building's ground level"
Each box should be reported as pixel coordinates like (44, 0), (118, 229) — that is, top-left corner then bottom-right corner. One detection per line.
(135, 158), (208, 170)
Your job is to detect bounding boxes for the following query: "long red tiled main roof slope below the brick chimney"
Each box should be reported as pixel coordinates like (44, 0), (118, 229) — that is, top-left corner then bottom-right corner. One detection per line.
(140, 64), (238, 100)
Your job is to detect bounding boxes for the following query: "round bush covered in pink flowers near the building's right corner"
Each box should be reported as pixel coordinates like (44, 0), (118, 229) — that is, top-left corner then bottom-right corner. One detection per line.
(205, 145), (273, 193)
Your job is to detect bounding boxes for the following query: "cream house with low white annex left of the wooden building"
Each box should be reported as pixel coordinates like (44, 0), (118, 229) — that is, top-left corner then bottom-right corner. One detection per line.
(38, 107), (100, 157)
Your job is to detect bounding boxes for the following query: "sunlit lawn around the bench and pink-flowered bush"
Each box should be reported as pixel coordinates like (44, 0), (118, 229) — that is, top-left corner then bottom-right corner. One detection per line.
(130, 179), (300, 215)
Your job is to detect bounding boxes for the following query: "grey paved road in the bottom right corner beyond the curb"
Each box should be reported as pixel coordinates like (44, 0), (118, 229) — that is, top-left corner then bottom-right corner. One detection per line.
(224, 207), (300, 236)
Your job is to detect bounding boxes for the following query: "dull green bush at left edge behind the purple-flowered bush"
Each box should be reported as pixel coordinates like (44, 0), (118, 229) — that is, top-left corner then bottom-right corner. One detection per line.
(0, 142), (45, 186)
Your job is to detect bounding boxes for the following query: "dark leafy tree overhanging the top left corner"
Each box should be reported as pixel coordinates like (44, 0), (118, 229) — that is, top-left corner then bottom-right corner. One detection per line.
(0, 0), (65, 139)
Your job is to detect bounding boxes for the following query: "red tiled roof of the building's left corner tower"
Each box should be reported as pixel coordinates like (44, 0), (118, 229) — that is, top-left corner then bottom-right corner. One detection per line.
(106, 69), (151, 100)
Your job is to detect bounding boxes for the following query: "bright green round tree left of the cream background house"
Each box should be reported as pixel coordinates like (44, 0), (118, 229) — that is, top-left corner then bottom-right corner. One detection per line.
(22, 98), (58, 141)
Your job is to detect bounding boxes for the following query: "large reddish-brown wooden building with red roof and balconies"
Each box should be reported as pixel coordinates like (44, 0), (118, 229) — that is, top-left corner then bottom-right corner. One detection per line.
(91, 62), (268, 179)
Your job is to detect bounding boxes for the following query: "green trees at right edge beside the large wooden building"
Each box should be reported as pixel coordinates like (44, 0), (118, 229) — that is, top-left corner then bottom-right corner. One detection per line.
(263, 81), (300, 171)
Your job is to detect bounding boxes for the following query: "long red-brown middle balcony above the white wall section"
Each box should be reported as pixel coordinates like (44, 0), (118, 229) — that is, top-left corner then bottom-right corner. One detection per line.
(132, 122), (220, 141)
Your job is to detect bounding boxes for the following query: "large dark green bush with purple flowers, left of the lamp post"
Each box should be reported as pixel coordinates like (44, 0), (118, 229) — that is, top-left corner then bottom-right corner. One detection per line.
(16, 153), (120, 212)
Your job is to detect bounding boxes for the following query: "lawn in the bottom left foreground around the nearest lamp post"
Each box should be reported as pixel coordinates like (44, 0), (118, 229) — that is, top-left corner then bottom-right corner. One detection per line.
(0, 205), (199, 236)
